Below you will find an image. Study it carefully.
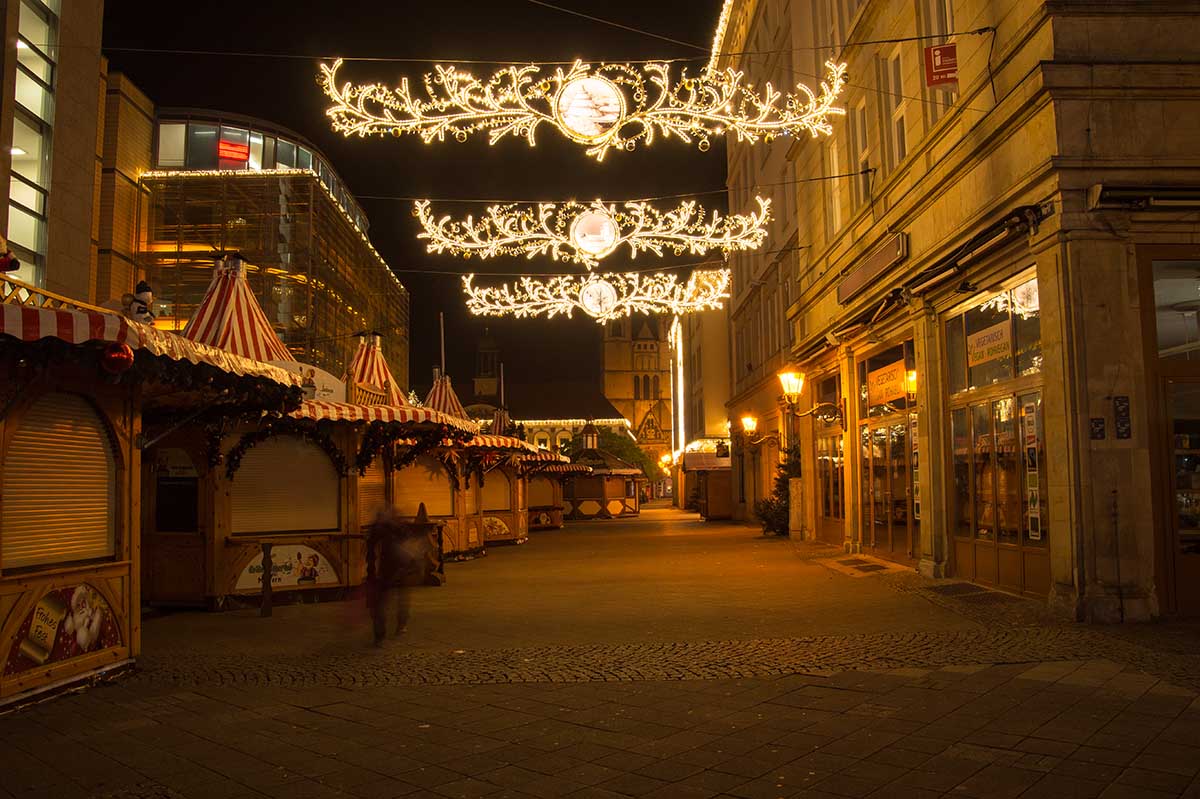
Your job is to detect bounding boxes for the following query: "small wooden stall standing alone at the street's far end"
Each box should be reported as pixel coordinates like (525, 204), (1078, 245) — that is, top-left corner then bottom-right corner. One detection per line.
(563, 422), (646, 519)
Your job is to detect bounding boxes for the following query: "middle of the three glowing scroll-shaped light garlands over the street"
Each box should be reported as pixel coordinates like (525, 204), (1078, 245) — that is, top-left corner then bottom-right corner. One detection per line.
(413, 197), (770, 269)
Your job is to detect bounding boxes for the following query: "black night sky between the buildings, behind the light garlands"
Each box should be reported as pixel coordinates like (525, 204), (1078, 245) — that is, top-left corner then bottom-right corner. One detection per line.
(104, 0), (725, 400)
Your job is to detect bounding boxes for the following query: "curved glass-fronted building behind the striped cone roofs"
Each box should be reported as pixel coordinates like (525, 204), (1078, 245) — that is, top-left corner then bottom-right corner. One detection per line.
(138, 110), (409, 389)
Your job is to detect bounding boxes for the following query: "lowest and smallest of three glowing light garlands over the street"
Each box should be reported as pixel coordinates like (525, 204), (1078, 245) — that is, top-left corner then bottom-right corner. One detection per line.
(462, 269), (730, 323)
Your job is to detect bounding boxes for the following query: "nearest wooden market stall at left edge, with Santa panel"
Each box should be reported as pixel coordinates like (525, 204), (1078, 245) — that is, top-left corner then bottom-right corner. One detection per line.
(0, 278), (301, 702)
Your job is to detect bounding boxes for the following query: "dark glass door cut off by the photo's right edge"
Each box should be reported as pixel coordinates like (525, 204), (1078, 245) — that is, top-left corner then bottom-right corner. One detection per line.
(1164, 380), (1200, 615)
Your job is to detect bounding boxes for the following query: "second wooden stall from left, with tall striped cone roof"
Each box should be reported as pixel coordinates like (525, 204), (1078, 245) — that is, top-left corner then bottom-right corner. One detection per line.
(144, 258), (473, 608)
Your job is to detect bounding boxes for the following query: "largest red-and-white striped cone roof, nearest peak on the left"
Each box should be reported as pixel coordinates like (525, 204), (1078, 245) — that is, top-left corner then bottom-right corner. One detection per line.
(182, 256), (296, 361)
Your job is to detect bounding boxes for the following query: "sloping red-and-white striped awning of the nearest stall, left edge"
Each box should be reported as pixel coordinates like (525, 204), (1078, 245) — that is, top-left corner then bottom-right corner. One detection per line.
(0, 289), (300, 385)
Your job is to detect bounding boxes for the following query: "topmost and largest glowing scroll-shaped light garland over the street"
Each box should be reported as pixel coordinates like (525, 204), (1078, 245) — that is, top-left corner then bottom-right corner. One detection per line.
(320, 59), (846, 161)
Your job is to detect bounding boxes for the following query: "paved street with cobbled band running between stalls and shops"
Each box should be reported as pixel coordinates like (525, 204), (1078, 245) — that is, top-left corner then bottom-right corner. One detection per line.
(0, 509), (1200, 799)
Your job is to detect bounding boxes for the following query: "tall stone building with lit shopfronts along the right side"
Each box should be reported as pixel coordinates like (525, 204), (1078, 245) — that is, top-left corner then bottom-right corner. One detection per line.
(719, 0), (1200, 620)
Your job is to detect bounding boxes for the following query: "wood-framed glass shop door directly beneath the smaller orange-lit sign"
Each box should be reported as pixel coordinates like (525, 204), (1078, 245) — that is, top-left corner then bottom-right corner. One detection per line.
(859, 414), (920, 561)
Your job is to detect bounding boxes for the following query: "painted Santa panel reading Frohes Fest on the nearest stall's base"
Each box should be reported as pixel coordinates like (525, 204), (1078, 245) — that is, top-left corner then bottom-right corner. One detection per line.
(4, 583), (121, 675)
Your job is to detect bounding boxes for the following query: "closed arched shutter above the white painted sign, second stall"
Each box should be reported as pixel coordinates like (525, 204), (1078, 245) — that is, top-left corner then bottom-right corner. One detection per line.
(230, 435), (341, 534)
